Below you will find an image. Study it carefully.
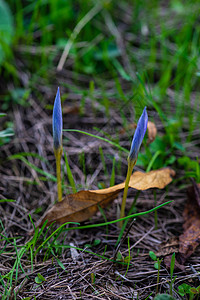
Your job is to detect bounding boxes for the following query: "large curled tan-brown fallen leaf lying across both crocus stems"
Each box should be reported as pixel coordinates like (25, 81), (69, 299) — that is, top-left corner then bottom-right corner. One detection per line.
(38, 168), (175, 227)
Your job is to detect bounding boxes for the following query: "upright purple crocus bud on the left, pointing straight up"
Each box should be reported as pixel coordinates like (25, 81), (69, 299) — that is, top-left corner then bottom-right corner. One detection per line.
(53, 87), (63, 150)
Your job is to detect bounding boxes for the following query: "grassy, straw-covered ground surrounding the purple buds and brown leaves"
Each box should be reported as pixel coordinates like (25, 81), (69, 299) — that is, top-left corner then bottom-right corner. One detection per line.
(0, 0), (200, 299)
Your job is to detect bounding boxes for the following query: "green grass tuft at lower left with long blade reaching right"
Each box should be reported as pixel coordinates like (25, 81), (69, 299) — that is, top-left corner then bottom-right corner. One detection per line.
(0, 202), (170, 299)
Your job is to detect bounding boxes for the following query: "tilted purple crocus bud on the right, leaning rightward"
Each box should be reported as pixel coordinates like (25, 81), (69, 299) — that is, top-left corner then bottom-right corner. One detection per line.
(128, 107), (148, 164)
